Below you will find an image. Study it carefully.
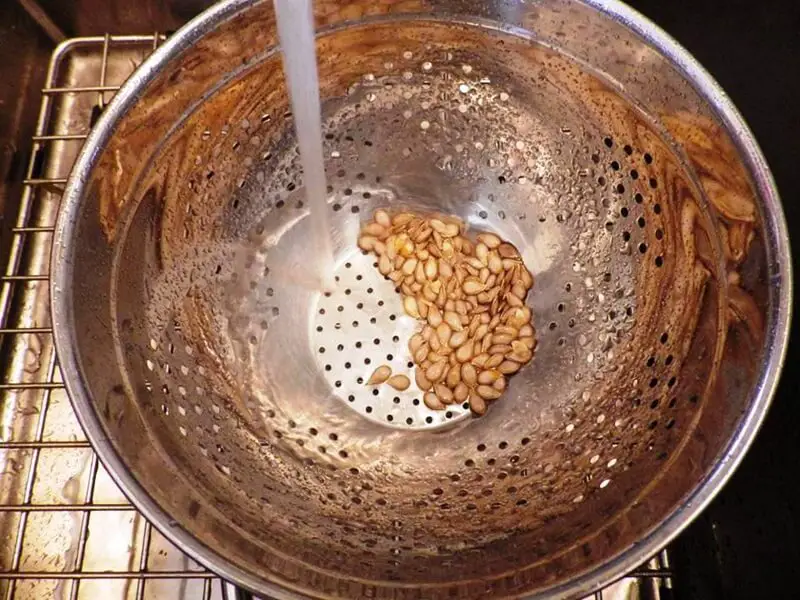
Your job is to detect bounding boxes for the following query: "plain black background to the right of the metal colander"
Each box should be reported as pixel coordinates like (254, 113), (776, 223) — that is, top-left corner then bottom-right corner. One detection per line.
(629, 0), (800, 600)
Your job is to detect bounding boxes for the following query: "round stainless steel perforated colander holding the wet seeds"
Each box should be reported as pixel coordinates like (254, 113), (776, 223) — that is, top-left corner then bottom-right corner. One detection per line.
(52, 0), (791, 599)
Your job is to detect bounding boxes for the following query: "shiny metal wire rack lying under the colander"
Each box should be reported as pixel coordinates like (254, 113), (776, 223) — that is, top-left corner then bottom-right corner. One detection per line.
(0, 33), (672, 600)
